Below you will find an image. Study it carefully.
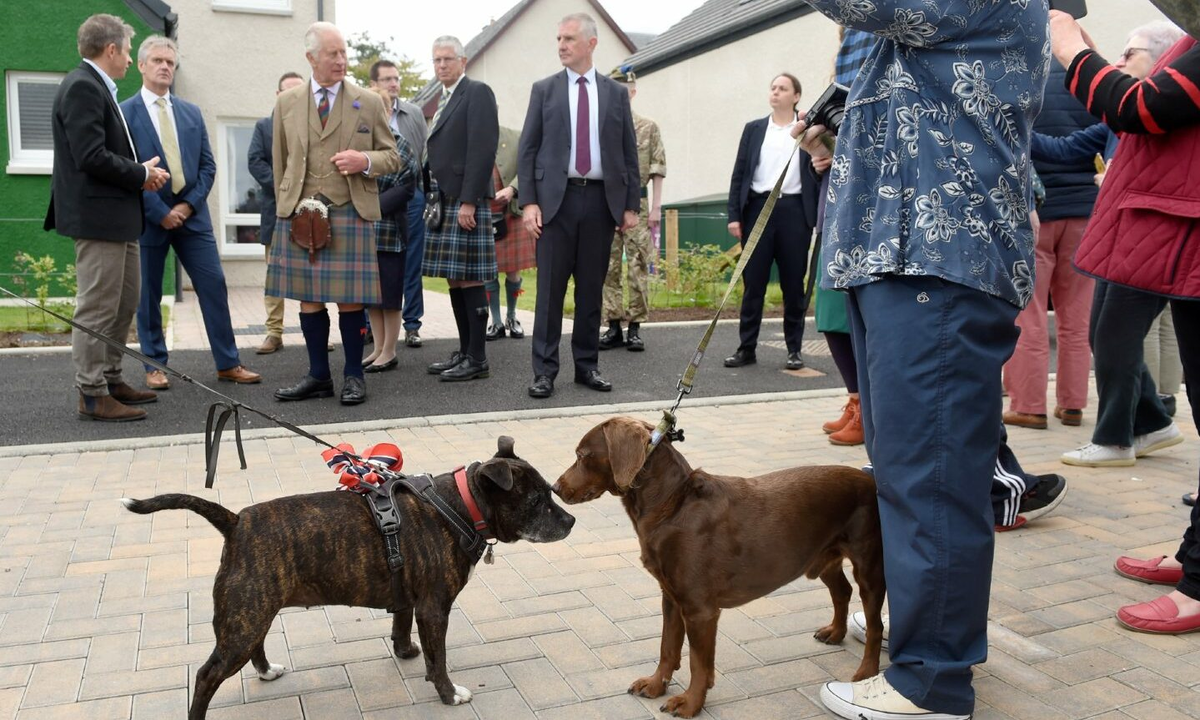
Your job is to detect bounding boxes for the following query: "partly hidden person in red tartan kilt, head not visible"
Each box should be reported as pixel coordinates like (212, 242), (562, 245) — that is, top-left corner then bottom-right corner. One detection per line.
(484, 127), (538, 342)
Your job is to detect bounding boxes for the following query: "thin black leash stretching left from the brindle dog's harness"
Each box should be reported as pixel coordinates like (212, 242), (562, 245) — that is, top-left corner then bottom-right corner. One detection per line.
(0, 286), (368, 488)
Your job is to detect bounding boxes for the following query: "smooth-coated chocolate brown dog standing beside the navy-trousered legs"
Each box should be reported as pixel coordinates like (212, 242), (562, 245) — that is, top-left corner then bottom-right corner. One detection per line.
(554, 418), (884, 718)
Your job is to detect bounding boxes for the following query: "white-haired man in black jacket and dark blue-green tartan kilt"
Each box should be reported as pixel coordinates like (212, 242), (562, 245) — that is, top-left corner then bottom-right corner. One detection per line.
(421, 35), (499, 382)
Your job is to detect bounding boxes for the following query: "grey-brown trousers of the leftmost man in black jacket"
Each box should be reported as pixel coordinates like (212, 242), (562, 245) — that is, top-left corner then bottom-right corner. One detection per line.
(71, 239), (142, 397)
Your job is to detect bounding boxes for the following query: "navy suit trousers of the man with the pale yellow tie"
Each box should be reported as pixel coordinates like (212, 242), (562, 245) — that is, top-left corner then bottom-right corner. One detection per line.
(138, 228), (241, 372)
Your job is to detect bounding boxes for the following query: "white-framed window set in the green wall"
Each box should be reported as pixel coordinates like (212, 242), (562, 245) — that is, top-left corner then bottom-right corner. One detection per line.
(5, 72), (66, 175)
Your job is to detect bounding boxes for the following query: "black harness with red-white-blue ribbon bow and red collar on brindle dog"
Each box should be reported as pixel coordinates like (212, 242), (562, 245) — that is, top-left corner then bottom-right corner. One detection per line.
(320, 443), (496, 612)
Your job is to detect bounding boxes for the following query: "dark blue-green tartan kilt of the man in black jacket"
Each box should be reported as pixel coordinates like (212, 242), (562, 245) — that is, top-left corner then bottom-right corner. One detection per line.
(421, 200), (496, 282)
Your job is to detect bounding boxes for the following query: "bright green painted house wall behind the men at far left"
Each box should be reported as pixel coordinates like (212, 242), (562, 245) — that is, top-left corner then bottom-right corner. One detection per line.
(0, 0), (174, 295)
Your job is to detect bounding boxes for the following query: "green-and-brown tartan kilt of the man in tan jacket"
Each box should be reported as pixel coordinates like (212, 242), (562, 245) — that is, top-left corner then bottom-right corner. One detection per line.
(266, 203), (379, 305)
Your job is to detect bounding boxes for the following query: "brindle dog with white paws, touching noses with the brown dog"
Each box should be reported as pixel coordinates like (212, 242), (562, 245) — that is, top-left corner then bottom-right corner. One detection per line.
(121, 437), (575, 720)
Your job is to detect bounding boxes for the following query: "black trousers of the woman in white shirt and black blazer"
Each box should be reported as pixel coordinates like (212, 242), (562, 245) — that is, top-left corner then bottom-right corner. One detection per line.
(738, 194), (812, 353)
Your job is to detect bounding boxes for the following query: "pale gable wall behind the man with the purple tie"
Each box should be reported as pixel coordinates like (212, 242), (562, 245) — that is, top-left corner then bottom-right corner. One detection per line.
(467, 0), (630, 130)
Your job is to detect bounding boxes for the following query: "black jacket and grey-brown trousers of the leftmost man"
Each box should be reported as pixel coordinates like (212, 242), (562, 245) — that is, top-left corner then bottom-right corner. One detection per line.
(44, 62), (146, 397)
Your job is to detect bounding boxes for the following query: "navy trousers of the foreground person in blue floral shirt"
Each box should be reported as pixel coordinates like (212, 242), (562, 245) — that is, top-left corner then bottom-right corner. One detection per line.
(847, 276), (1018, 715)
